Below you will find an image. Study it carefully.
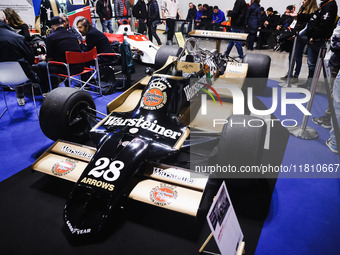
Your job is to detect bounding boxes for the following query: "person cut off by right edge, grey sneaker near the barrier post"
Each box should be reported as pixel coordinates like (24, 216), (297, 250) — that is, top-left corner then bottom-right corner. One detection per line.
(312, 20), (340, 129)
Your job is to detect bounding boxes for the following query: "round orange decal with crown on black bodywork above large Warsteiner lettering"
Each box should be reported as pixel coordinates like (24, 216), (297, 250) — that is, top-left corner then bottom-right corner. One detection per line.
(141, 78), (171, 110)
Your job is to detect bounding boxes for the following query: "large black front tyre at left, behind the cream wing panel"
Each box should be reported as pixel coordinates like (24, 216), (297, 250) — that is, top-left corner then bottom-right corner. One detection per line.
(39, 87), (96, 142)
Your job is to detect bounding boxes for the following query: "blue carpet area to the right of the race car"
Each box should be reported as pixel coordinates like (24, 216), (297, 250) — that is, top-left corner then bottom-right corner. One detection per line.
(256, 81), (340, 255)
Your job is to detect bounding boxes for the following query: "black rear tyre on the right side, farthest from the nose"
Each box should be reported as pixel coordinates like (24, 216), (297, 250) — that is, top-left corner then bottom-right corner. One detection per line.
(242, 53), (271, 92)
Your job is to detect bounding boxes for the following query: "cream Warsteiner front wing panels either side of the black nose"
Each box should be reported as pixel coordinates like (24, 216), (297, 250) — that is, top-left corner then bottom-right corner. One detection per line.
(32, 140), (208, 216)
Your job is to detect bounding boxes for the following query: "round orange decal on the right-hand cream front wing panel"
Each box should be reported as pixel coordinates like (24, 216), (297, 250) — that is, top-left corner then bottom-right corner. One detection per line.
(150, 183), (178, 206)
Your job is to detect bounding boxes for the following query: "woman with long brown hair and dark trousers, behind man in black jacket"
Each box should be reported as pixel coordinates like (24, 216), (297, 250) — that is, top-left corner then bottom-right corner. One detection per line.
(281, 0), (318, 83)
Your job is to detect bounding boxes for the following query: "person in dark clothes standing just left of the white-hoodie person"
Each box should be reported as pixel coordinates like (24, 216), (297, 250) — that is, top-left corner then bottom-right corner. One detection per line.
(147, 0), (162, 46)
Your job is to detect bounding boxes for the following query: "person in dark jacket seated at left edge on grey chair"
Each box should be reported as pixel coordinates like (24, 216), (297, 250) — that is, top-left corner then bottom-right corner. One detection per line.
(0, 11), (40, 106)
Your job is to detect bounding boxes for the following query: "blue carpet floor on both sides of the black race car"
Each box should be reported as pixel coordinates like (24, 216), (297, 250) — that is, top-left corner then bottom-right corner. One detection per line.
(0, 78), (340, 255)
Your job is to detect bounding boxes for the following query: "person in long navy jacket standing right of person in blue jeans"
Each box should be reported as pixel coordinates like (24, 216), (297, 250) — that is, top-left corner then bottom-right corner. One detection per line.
(246, 0), (261, 50)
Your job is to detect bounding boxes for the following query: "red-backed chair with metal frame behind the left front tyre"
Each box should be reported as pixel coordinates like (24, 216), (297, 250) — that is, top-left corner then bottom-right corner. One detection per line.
(47, 47), (102, 95)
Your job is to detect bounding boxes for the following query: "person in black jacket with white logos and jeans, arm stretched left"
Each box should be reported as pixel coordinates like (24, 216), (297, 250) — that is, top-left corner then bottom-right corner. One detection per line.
(290, 0), (338, 87)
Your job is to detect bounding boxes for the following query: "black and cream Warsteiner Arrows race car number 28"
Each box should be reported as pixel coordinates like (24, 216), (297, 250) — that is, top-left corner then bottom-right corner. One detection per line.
(33, 35), (270, 235)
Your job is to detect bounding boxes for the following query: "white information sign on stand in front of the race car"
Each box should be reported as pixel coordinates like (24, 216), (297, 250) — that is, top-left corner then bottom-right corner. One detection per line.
(200, 182), (244, 255)
